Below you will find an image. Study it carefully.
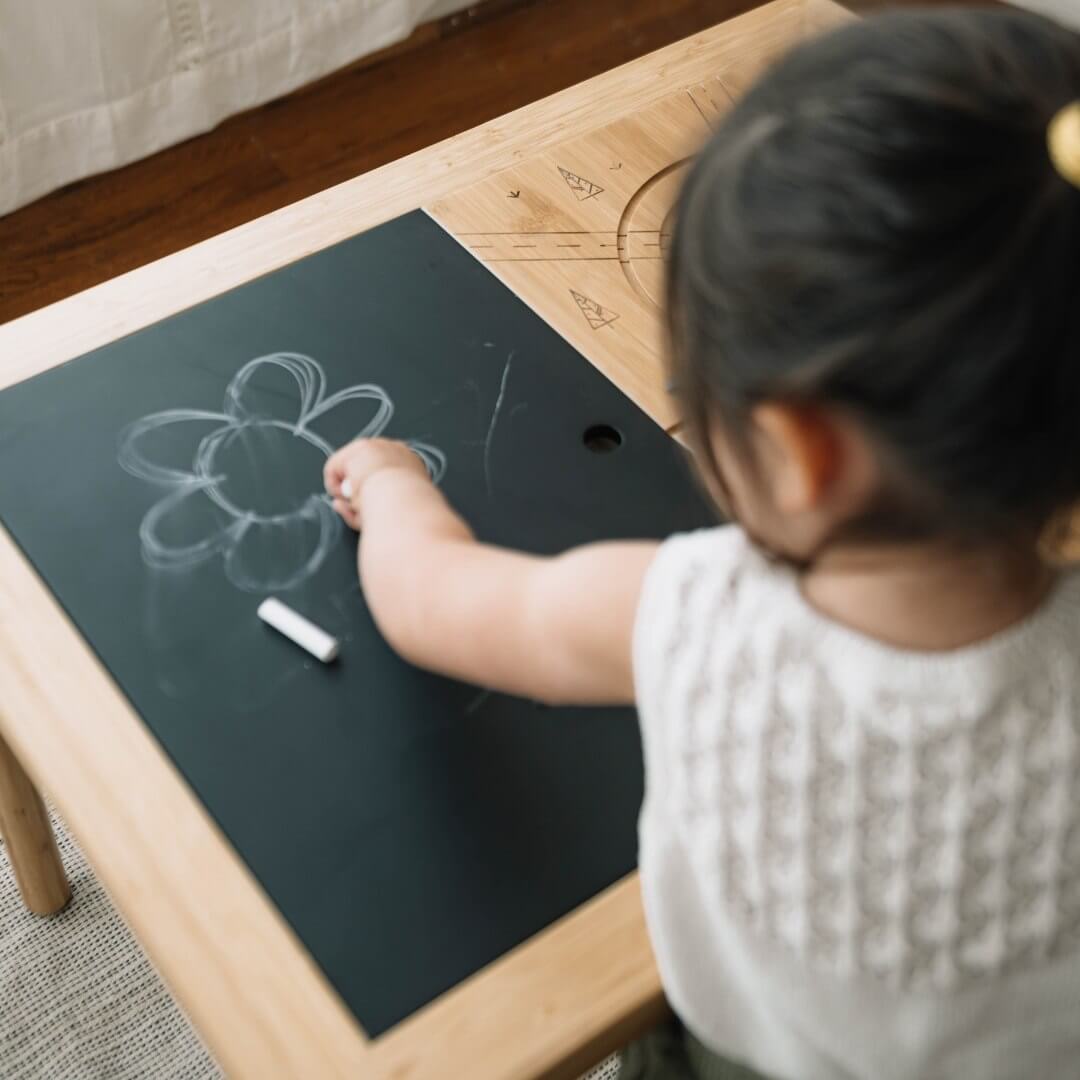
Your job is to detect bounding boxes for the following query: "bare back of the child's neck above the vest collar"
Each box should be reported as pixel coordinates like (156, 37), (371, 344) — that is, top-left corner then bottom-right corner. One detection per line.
(801, 542), (1055, 651)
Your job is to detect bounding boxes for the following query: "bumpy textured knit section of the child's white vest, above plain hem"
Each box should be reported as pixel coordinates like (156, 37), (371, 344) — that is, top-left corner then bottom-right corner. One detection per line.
(636, 529), (1080, 990)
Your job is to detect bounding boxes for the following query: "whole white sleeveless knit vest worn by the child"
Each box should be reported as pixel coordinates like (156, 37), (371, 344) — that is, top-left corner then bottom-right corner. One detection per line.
(634, 527), (1080, 1080)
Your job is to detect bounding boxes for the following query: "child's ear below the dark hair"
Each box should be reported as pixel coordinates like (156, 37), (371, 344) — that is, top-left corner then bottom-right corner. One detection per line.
(751, 403), (845, 514)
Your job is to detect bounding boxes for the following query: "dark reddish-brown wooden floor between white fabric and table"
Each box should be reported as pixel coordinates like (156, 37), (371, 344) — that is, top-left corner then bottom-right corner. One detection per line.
(0, 0), (756, 322)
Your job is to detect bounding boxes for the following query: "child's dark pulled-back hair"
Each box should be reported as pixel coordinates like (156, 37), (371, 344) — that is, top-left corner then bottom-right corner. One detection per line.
(669, 9), (1080, 537)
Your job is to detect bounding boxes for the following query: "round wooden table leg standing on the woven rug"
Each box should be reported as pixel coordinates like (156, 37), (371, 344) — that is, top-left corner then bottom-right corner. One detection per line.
(0, 738), (71, 915)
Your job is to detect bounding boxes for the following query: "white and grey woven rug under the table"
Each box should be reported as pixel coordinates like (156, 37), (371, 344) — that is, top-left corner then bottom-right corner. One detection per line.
(0, 813), (619, 1080)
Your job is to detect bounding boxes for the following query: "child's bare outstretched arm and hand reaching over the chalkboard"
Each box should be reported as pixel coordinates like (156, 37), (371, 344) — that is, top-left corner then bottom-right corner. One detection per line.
(325, 440), (657, 704)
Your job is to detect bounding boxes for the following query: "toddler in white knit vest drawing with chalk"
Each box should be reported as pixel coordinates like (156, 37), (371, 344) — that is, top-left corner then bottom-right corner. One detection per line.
(325, 8), (1080, 1080)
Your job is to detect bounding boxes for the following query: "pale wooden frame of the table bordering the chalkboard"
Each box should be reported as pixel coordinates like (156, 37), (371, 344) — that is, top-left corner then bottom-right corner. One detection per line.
(0, 0), (838, 1080)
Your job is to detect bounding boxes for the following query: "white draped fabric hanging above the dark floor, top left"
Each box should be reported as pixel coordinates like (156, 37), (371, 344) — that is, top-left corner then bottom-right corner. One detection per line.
(0, 0), (468, 214)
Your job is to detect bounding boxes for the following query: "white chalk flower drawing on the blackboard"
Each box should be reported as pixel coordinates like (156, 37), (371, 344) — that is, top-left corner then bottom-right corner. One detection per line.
(119, 352), (446, 592)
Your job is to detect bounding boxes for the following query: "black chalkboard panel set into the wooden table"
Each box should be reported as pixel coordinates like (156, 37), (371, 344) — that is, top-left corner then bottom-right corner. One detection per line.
(0, 212), (711, 1036)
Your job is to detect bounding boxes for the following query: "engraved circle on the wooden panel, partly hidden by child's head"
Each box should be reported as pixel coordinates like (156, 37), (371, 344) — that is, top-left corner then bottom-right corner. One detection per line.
(619, 159), (690, 311)
